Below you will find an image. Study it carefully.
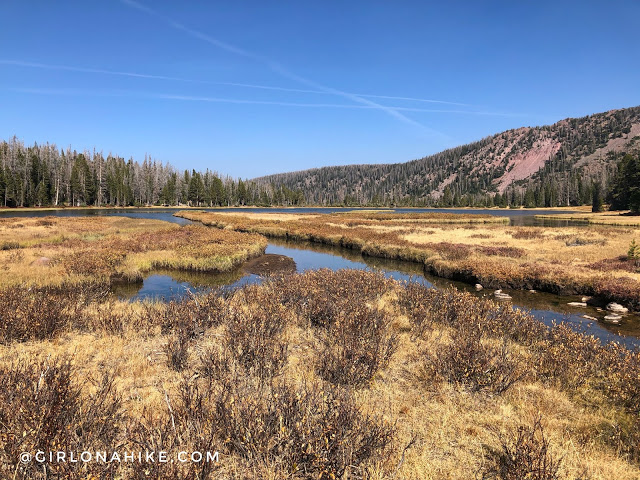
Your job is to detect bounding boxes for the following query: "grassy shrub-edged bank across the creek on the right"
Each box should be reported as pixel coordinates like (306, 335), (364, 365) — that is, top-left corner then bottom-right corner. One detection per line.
(176, 211), (640, 310)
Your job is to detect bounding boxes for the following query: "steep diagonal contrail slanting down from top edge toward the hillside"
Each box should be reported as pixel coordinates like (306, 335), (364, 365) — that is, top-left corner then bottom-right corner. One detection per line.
(120, 0), (449, 138)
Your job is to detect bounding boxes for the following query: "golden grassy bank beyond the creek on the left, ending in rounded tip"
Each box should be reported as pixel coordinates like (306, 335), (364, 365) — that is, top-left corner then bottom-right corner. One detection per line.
(0, 217), (266, 287)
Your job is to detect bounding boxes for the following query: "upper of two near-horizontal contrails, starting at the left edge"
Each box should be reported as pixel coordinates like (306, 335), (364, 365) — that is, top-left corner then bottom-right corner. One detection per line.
(0, 60), (473, 107)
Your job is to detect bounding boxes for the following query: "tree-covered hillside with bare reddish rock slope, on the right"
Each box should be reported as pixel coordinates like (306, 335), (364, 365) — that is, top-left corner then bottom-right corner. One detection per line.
(256, 107), (640, 207)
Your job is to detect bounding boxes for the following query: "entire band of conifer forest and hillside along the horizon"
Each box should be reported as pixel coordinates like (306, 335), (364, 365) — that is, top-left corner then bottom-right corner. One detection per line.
(5, 107), (640, 207)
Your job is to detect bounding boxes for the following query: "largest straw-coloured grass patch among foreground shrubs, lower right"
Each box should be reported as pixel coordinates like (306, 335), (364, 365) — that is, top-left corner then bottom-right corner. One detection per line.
(364, 318), (640, 480)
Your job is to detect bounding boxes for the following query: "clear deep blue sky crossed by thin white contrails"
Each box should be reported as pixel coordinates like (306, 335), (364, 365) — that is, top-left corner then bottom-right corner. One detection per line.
(0, 0), (640, 178)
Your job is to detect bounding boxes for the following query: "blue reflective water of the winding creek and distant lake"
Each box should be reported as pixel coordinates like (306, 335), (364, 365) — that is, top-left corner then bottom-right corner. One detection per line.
(0, 208), (640, 347)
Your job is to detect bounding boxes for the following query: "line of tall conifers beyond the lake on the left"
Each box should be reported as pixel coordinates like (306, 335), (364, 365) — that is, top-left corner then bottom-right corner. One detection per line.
(0, 137), (303, 207)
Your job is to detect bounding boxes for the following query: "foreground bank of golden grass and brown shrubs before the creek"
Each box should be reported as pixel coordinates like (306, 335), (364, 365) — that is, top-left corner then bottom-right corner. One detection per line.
(0, 271), (640, 480)
